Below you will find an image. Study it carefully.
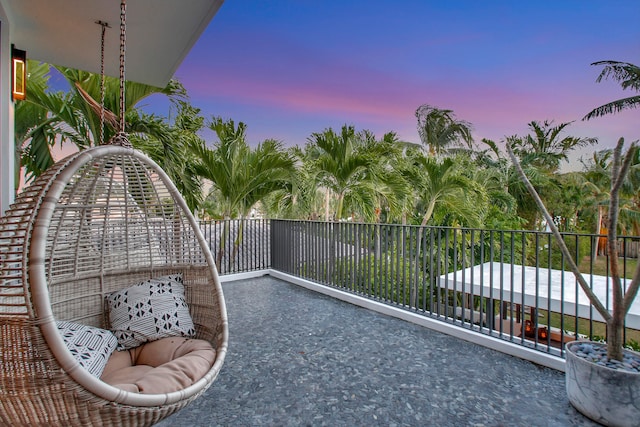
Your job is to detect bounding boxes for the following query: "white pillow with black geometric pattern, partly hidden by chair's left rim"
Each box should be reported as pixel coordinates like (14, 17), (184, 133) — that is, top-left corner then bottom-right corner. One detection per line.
(56, 320), (118, 378)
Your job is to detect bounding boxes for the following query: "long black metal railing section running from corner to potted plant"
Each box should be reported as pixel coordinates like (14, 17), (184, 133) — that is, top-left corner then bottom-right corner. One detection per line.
(271, 220), (640, 355)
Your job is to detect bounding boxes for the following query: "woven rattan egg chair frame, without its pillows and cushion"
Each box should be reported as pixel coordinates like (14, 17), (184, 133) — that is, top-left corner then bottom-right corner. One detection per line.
(0, 145), (228, 425)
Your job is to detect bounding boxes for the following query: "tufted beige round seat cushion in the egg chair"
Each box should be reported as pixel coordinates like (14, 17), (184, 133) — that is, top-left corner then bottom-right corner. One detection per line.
(101, 337), (216, 394)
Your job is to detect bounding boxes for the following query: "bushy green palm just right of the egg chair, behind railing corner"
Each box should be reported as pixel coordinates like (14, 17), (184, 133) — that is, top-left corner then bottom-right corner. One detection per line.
(194, 117), (294, 268)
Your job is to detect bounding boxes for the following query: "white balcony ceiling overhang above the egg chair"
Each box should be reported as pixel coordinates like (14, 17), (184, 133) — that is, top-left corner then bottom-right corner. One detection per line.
(0, 0), (224, 87)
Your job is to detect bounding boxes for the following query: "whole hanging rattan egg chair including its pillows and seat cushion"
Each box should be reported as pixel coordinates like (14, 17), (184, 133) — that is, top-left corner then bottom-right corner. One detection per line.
(0, 2), (228, 426)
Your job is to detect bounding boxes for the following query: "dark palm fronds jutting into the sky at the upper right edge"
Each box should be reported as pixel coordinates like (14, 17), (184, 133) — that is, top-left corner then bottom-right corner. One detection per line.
(582, 61), (640, 120)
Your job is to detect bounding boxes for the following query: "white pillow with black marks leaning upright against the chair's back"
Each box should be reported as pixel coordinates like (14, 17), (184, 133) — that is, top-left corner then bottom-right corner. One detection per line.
(107, 274), (196, 350)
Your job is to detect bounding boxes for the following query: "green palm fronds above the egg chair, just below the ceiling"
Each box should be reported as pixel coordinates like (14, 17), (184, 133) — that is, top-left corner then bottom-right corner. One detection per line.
(15, 61), (186, 186)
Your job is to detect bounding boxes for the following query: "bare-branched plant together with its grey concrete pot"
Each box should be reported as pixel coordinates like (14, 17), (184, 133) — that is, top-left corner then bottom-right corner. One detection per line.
(507, 138), (640, 426)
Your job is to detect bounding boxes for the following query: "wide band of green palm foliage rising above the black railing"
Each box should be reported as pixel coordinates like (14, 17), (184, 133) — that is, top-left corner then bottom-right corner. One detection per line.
(15, 61), (640, 241)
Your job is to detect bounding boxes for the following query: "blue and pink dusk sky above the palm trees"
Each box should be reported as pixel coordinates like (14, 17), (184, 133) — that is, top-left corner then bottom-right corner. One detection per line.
(148, 0), (640, 171)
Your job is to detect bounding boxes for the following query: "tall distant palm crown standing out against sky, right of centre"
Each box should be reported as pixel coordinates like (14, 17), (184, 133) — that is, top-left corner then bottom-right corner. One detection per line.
(415, 104), (473, 156)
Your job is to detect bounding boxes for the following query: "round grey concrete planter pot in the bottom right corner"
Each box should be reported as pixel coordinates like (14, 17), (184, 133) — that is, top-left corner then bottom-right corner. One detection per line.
(566, 341), (640, 427)
